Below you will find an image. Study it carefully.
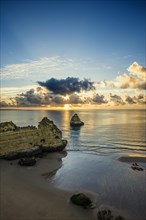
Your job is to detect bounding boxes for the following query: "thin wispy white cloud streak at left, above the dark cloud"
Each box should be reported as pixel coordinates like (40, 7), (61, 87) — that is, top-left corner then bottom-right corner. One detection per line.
(1, 56), (73, 80)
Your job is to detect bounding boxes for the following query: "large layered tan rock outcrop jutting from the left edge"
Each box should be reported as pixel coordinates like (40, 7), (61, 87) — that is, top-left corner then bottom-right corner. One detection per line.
(0, 117), (67, 159)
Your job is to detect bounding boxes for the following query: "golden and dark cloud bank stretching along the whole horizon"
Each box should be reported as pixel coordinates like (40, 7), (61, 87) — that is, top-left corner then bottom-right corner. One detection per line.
(0, 59), (146, 107)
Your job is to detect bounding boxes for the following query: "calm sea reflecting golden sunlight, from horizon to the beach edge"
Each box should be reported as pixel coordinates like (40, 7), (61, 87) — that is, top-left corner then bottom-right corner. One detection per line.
(1, 110), (146, 155)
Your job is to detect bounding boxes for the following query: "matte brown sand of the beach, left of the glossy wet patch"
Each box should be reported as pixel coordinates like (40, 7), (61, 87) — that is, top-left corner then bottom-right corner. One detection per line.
(0, 151), (145, 220)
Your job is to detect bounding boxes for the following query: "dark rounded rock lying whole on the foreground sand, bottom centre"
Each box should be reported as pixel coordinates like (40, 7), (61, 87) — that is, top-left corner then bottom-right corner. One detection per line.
(70, 193), (93, 208)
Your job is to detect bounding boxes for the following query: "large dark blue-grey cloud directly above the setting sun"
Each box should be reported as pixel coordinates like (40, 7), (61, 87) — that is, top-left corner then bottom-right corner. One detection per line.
(38, 77), (95, 95)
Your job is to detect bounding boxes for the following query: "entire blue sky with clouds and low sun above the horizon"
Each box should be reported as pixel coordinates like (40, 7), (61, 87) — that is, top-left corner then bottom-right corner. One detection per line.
(1, 0), (146, 109)
